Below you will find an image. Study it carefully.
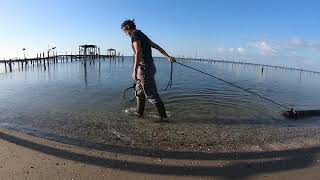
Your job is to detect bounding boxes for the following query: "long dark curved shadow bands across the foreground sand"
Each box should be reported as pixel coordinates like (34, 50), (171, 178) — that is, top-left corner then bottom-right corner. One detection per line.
(0, 129), (320, 178)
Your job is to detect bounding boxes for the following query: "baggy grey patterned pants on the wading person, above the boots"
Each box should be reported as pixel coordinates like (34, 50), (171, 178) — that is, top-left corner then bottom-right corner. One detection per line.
(136, 63), (162, 104)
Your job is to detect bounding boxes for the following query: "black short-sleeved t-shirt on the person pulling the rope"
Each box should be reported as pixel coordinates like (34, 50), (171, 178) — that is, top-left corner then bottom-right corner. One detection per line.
(131, 30), (153, 64)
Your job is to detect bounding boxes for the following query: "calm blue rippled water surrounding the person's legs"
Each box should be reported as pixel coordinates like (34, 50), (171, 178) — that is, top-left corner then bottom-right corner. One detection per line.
(0, 57), (320, 150)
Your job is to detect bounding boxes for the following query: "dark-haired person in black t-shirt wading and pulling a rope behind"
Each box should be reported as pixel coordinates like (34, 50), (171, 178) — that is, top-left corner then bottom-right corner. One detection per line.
(121, 20), (176, 122)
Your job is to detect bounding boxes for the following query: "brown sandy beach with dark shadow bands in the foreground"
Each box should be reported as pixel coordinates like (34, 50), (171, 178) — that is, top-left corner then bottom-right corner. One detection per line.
(0, 129), (320, 180)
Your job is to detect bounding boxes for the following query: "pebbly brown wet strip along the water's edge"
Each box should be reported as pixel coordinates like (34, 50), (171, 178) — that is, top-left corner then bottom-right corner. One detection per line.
(2, 112), (320, 153)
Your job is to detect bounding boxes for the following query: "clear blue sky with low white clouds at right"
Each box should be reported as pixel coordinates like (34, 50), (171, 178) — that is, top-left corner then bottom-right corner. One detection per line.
(0, 0), (320, 70)
